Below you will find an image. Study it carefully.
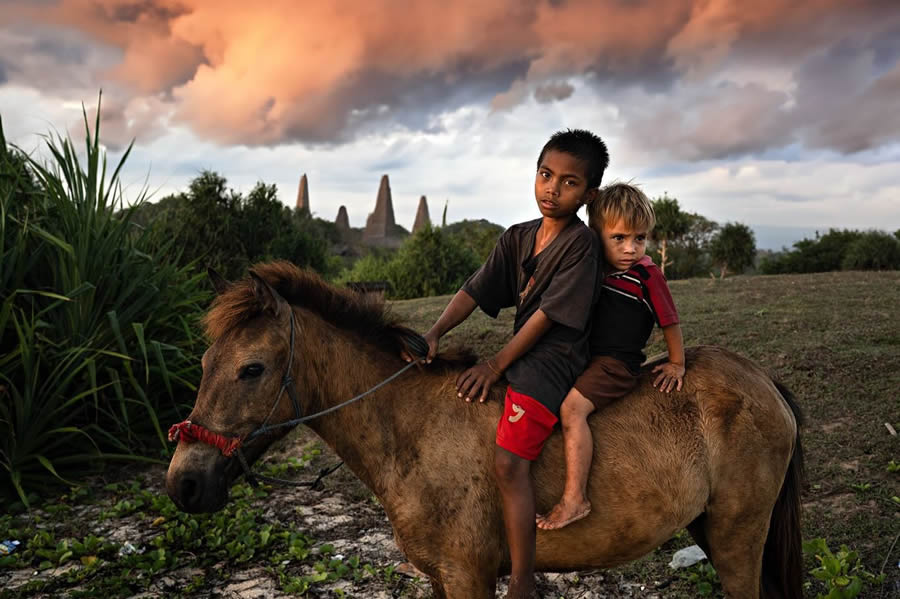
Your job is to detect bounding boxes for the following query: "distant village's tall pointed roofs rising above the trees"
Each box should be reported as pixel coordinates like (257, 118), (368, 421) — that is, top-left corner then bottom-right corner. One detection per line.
(297, 173), (431, 248)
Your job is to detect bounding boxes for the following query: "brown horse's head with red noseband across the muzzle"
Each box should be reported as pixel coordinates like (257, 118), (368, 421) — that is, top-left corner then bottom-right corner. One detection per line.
(166, 271), (295, 512)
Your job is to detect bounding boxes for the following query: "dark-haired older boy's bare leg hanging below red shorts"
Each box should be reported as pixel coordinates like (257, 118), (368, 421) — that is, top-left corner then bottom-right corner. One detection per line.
(494, 446), (535, 599)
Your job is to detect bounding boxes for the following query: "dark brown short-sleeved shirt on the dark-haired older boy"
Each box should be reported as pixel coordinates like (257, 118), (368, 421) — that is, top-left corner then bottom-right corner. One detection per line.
(463, 217), (599, 416)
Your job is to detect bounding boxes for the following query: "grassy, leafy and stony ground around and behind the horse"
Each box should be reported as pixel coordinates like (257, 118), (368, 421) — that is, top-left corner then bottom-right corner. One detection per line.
(0, 272), (900, 599)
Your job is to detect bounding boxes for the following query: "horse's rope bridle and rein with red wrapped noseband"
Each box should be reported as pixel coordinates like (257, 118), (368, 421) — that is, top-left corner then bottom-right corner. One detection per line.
(169, 311), (428, 489)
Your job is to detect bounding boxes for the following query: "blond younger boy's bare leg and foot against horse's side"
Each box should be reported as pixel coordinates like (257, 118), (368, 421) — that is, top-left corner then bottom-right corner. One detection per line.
(537, 388), (594, 530)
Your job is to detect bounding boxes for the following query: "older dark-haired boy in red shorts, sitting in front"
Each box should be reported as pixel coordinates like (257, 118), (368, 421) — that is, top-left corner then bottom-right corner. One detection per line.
(414, 130), (609, 599)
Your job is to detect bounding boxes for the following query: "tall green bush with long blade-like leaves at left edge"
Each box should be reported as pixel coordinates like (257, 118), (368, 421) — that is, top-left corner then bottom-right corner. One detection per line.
(0, 105), (210, 505)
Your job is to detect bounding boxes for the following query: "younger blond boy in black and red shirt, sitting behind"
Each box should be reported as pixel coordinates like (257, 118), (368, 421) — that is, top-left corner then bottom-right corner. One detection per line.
(537, 184), (684, 530)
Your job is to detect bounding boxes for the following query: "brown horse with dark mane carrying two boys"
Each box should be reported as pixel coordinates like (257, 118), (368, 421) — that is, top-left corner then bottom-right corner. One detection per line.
(166, 262), (803, 599)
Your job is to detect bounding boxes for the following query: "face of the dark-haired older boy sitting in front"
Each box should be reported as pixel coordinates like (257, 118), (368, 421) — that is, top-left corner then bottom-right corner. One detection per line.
(534, 150), (597, 218)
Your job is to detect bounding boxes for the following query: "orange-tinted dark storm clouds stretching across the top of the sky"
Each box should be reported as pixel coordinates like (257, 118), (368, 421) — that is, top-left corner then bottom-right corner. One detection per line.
(0, 0), (900, 160)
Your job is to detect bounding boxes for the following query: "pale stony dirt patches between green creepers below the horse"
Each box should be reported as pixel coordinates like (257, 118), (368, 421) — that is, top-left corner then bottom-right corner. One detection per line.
(0, 429), (676, 599)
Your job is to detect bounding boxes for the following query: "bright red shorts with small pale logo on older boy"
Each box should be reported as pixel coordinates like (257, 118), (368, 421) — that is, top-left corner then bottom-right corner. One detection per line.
(497, 387), (557, 460)
